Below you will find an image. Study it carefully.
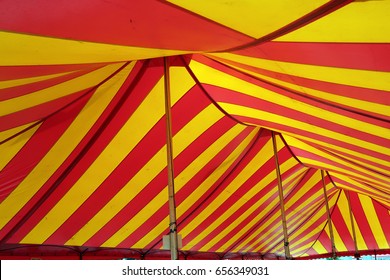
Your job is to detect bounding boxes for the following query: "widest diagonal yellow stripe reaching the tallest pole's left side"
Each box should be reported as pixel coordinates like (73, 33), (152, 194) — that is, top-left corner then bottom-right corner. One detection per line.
(23, 63), (175, 243)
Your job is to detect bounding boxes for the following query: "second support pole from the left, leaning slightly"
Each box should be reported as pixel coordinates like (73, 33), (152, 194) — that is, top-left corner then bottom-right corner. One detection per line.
(272, 131), (291, 260)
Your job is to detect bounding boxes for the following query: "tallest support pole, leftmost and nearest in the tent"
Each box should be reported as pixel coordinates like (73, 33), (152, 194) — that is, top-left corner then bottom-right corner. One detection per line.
(164, 57), (179, 260)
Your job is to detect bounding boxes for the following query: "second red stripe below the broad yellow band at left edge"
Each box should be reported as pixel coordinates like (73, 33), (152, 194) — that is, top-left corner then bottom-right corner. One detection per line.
(0, 67), (105, 101)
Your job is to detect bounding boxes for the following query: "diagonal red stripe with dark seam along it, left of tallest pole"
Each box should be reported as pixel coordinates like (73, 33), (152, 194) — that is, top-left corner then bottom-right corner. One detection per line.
(7, 63), (149, 242)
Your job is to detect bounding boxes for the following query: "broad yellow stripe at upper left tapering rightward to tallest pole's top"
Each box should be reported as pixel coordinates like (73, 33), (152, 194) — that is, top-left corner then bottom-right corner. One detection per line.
(0, 31), (191, 66)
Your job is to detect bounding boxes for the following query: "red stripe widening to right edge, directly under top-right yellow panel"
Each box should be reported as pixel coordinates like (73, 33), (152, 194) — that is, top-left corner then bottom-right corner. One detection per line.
(235, 42), (390, 72)
